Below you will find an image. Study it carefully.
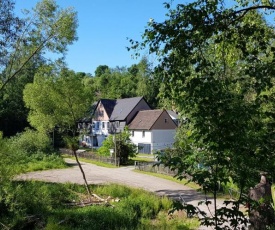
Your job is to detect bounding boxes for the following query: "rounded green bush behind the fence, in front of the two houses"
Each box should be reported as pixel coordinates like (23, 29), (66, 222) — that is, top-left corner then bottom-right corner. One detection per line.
(98, 127), (137, 164)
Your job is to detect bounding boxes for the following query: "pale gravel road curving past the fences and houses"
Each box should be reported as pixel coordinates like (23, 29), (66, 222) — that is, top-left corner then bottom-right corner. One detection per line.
(20, 159), (230, 229)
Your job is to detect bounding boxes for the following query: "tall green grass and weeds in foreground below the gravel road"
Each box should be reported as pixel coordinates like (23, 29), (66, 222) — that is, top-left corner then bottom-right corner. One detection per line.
(0, 181), (198, 230)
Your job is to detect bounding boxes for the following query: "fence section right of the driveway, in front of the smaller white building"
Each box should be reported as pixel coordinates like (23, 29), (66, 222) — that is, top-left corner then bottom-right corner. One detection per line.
(135, 161), (177, 176)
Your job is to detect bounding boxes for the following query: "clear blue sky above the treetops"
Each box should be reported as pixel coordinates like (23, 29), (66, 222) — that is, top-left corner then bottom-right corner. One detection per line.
(15, 0), (185, 75)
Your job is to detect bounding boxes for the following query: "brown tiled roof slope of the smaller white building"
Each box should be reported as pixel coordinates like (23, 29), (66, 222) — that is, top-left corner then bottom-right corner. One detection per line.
(129, 109), (165, 130)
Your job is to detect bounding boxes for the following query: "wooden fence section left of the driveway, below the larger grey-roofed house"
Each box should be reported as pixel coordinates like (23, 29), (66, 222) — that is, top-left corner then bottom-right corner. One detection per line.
(60, 149), (119, 165)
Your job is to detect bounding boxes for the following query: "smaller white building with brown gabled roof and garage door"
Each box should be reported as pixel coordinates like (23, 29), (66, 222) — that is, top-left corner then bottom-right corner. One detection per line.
(128, 110), (177, 154)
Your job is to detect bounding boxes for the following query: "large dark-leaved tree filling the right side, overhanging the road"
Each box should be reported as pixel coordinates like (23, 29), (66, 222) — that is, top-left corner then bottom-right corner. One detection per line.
(131, 0), (275, 229)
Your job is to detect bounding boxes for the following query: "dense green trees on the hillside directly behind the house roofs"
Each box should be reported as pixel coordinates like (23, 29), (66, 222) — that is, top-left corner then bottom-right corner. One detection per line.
(91, 57), (159, 107)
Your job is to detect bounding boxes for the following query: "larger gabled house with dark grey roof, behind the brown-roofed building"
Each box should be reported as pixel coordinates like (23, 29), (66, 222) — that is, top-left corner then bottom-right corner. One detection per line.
(90, 97), (151, 146)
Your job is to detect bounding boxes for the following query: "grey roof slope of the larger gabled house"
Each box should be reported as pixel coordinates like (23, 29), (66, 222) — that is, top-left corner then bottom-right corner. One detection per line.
(109, 97), (146, 121)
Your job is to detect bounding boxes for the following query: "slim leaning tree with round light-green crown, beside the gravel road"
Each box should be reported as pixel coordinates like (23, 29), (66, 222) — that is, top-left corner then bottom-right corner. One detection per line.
(24, 65), (95, 197)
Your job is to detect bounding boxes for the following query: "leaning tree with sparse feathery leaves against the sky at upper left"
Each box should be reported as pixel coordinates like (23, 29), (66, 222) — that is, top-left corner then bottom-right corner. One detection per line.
(0, 0), (77, 90)
